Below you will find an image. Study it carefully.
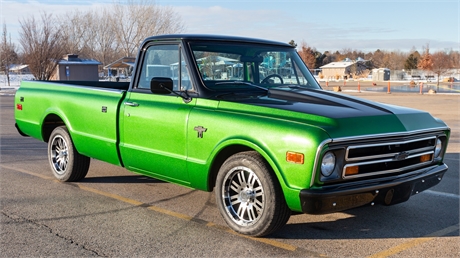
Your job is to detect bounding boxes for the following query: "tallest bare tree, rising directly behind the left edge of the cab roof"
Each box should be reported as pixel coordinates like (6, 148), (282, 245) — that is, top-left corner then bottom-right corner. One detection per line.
(112, 0), (183, 56)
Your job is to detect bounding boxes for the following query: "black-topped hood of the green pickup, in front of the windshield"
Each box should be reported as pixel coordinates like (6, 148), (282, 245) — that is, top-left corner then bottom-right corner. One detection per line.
(217, 88), (446, 138)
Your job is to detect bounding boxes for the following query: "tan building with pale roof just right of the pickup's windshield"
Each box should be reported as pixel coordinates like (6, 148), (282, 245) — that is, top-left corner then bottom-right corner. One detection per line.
(320, 58), (368, 80)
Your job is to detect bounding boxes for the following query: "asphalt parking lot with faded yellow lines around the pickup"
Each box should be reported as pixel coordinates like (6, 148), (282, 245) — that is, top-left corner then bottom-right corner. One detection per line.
(0, 90), (460, 257)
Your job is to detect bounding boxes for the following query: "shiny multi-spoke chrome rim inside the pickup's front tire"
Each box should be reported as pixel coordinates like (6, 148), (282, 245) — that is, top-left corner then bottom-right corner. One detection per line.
(222, 166), (265, 226)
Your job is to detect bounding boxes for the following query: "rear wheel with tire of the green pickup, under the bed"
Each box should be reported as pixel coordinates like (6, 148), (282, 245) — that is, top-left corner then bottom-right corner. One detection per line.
(48, 126), (90, 182)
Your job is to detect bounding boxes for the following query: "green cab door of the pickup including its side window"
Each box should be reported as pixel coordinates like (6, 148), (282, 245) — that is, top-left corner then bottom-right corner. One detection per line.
(120, 43), (195, 185)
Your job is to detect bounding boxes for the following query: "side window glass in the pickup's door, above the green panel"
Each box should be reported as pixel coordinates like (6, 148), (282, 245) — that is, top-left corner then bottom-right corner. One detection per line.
(137, 45), (191, 91)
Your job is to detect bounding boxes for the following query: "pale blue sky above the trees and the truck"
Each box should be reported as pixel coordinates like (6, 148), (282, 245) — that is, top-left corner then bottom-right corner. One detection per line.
(0, 0), (460, 52)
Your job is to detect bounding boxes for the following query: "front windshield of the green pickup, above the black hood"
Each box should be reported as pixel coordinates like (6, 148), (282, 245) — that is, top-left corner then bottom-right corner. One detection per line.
(190, 42), (320, 90)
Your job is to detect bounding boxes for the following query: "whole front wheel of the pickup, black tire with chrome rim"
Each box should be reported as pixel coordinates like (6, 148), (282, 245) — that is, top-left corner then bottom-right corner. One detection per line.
(215, 151), (291, 236)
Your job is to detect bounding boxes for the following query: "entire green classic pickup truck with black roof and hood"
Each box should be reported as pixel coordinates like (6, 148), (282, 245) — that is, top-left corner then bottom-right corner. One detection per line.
(15, 35), (450, 236)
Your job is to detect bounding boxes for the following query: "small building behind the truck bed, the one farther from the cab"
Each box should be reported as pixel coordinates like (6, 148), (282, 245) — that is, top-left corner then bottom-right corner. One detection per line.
(51, 54), (102, 81)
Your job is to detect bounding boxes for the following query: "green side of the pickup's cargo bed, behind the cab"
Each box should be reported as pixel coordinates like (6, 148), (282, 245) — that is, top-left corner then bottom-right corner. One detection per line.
(15, 81), (129, 165)
